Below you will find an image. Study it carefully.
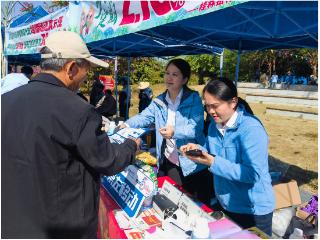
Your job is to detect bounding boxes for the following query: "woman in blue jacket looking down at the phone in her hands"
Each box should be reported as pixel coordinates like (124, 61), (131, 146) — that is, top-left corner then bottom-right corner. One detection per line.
(180, 79), (274, 235)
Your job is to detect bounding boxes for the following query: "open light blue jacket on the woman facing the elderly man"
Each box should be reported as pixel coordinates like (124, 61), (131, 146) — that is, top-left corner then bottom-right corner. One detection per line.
(126, 87), (206, 176)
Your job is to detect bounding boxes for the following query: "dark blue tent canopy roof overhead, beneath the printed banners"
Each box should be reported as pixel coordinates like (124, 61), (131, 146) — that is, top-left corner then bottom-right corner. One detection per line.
(8, 1), (318, 65)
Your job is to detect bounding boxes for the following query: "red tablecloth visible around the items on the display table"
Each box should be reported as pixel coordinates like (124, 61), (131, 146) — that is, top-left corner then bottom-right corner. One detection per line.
(98, 176), (212, 239)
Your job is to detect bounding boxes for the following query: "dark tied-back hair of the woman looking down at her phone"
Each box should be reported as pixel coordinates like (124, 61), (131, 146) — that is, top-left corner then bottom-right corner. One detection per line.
(202, 77), (253, 115)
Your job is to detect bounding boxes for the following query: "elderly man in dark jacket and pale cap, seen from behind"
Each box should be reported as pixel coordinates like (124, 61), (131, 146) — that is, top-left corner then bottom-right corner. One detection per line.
(1, 31), (139, 238)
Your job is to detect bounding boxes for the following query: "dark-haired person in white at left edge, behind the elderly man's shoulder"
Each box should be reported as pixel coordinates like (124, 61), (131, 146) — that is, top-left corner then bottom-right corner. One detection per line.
(1, 66), (33, 95)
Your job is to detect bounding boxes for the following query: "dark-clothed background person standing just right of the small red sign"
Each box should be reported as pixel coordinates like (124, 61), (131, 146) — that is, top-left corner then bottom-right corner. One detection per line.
(119, 77), (131, 120)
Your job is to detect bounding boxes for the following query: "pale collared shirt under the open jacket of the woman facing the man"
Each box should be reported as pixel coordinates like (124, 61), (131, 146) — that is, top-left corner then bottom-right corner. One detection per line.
(164, 89), (183, 166)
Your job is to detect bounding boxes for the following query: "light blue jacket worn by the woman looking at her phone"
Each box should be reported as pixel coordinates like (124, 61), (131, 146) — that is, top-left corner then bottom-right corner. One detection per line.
(206, 105), (275, 215)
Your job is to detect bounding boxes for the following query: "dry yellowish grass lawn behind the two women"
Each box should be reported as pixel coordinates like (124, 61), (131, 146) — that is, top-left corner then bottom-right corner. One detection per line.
(130, 84), (318, 193)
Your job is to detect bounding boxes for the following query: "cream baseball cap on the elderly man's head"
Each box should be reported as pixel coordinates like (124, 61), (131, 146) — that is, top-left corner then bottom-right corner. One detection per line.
(41, 31), (109, 68)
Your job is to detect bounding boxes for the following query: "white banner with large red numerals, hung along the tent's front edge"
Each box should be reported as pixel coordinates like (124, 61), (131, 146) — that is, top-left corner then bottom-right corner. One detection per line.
(69, 0), (240, 42)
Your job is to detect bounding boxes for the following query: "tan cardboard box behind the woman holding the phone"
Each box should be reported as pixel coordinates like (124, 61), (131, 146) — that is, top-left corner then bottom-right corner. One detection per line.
(273, 180), (301, 209)
